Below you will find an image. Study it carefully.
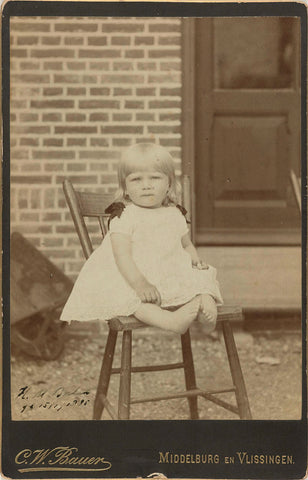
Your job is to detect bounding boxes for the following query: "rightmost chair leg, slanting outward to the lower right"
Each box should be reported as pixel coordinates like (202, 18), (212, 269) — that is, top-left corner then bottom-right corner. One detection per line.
(222, 321), (252, 420)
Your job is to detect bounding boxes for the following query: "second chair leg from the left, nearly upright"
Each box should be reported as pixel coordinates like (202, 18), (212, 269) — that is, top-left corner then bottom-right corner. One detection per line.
(118, 330), (132, 420)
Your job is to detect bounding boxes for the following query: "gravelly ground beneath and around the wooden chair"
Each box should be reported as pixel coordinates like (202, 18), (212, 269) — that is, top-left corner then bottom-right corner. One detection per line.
(11, 323), (301, 420)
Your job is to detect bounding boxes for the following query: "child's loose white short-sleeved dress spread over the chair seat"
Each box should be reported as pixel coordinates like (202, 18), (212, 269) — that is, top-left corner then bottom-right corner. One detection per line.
(61, 204), (223, 322)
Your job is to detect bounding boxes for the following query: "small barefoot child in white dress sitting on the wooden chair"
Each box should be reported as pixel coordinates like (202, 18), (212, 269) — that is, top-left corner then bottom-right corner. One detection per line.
(61, 143), (223, 334)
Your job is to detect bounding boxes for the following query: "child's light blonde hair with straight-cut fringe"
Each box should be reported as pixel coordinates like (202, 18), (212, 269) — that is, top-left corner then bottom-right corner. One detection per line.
(115, 143), (181, 205)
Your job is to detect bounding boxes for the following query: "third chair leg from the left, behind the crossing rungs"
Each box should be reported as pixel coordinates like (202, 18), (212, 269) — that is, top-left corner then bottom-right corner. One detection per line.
(181, 330), (199, 420)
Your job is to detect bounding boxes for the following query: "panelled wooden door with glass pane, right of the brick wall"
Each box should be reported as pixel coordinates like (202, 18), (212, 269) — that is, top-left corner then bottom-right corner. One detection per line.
(194, 17), (300, 244)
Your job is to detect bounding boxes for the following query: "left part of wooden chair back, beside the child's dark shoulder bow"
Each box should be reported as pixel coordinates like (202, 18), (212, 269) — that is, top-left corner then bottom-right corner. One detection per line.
(63, 179), (113, 258)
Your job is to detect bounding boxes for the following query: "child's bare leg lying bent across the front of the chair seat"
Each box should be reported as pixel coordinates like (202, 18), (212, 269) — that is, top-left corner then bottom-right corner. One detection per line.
(134, 295), (200, 334)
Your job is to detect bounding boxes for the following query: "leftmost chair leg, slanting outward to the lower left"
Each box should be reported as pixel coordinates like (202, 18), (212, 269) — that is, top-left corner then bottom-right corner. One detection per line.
(93, 330), (118, 420)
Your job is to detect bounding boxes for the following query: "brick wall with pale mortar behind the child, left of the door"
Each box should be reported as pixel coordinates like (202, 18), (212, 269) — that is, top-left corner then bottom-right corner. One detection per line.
(10, 17), (181, 279)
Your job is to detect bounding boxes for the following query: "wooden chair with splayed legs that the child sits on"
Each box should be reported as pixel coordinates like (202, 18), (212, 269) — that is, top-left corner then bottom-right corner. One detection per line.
(63, 179), (251, 420)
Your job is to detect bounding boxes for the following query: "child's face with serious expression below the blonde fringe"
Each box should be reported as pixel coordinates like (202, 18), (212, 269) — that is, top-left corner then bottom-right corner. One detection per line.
(125, 170), (169, 208)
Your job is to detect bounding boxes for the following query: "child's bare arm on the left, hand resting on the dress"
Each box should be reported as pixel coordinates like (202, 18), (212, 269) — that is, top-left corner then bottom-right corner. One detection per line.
(110, 233), (161, 305)
